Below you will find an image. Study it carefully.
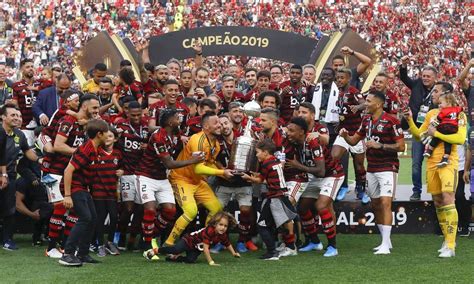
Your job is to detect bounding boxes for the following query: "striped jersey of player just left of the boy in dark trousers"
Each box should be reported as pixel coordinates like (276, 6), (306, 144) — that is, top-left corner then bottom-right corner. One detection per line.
(43, 115), (87, 176)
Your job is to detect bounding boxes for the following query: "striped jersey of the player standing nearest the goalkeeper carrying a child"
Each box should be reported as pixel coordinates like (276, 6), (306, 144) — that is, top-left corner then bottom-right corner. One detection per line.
(357, 112), (403, 173)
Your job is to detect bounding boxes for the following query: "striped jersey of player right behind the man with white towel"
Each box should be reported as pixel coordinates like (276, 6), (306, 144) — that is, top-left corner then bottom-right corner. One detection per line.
(337, 86), (364, 135)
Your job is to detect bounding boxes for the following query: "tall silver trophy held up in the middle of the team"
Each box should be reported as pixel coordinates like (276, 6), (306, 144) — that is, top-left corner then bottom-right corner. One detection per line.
(230, 101), (260, 172)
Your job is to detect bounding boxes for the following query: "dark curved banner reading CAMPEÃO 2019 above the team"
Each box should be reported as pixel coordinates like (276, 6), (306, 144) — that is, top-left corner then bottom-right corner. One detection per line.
(149, 27), (329, 64)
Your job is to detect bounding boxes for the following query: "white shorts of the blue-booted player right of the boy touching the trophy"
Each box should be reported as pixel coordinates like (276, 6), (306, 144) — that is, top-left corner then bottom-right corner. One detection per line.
(301, 176), (344, 200)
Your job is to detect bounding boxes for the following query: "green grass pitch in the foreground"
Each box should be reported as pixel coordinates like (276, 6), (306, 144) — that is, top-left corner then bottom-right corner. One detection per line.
(0, 235), (474, 283)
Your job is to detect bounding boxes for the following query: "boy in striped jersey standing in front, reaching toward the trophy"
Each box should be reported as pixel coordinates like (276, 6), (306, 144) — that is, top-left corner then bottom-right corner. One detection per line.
(242, 139), (297, 260)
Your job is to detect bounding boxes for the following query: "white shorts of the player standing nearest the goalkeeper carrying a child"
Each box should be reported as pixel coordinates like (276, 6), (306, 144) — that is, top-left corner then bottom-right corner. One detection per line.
(365, 172), (398, 198)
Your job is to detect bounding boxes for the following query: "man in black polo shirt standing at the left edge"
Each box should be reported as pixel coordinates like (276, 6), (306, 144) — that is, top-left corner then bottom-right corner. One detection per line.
(0, 104), (39, 250)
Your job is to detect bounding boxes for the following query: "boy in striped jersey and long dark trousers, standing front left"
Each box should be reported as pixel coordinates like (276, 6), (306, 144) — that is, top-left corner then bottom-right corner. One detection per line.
(59, 119), (109, 266)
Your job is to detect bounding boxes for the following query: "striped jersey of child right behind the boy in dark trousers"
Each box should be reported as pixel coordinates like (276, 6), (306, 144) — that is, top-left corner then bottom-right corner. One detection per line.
(91, 148), (122, 200)
